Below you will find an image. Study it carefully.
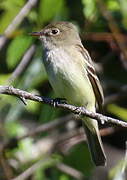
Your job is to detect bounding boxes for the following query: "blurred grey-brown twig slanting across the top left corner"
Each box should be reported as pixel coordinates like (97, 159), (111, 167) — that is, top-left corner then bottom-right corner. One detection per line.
(0, 0), (37, 49)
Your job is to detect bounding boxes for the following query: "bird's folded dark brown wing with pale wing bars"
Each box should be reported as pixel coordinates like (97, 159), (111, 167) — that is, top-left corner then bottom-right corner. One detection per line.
(76, 45), (104, 111)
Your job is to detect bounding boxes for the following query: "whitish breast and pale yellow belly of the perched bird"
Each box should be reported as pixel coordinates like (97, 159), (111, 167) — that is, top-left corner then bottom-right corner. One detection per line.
(44, 48), (94, 107)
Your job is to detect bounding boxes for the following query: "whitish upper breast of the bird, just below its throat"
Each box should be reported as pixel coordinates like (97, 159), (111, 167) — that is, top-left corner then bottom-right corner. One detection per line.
(44, 48), (77, 82)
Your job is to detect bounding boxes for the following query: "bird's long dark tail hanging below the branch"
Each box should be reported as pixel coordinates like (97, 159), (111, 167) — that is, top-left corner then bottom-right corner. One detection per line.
(83, 117), (106, 166)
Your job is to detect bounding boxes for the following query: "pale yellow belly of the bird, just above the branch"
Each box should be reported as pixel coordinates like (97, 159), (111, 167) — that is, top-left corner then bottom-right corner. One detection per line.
(48, 60), (95, 109)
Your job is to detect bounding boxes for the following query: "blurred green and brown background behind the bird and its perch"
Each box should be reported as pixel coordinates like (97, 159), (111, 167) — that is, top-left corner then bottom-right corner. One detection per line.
(0, 0), (127, 180)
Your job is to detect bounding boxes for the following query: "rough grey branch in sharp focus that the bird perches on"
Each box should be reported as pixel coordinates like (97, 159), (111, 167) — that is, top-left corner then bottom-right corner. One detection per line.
(0, 86), (127, 127)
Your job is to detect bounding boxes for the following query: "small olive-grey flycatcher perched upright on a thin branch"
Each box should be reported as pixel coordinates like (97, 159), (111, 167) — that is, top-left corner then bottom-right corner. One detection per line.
(31, 22), (106, 166)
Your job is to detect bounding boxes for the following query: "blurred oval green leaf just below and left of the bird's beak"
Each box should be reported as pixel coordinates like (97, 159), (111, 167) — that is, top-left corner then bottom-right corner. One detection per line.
(7, 35), (32, 68)
